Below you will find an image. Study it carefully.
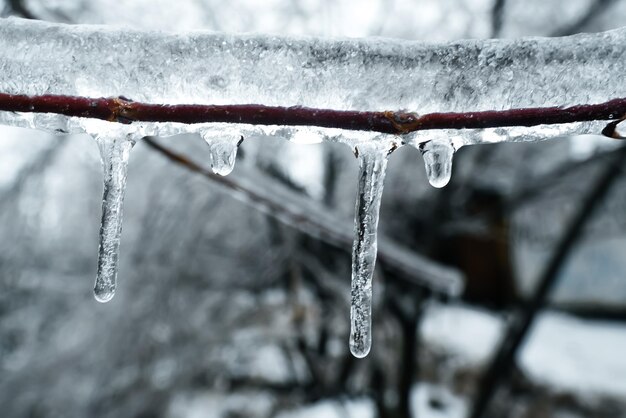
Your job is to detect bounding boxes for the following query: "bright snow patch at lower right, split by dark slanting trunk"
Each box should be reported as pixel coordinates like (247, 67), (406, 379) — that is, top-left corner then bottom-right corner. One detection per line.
(420, 304), (626, 397)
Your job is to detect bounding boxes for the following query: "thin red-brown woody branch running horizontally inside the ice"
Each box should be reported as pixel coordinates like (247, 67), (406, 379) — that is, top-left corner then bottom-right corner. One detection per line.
(0, 93), (626, 136)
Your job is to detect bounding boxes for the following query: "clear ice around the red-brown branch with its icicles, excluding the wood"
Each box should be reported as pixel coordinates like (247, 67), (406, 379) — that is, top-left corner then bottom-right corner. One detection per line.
(0, 18), (626, 350)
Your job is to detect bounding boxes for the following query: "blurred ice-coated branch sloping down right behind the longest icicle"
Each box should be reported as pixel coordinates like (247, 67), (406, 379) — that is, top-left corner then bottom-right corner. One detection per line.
(144, 137), (463, 295)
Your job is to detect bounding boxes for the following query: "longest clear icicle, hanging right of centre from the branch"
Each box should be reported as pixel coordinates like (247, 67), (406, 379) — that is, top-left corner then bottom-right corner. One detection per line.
(350, 143), (389, 358)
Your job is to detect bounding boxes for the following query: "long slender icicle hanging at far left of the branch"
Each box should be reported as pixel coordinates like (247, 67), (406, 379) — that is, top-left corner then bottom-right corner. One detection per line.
(93, 136), (135, 303)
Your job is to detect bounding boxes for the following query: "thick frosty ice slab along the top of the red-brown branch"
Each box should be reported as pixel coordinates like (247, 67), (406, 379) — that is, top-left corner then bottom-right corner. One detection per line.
(0, 18), (626, 143)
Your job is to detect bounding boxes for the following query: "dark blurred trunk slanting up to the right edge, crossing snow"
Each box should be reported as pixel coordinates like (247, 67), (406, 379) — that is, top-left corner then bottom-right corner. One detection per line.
(471, 147), (626, 418)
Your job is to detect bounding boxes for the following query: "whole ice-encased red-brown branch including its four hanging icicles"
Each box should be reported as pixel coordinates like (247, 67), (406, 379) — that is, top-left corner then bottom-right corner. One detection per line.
(0, 15), (626, 356)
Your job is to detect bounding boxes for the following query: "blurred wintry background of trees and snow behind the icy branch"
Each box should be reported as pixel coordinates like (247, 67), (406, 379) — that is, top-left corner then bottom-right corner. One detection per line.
(0, 0), (626, 418)
